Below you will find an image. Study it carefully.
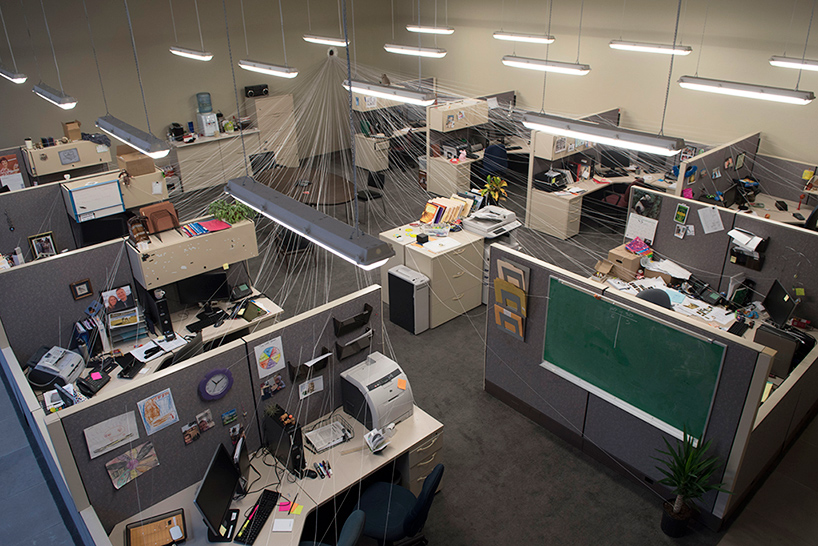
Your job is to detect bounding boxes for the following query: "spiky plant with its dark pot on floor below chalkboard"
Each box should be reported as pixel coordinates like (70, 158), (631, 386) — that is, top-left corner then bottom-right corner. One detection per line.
(653, 429), (729, 537)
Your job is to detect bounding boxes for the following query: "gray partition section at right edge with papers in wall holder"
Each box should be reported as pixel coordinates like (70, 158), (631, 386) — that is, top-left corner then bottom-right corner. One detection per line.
(719, 213), (818, 324)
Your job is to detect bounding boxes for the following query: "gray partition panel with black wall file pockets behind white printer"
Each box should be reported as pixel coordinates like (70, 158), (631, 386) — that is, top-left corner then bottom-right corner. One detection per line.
(244, 285), (382, 425)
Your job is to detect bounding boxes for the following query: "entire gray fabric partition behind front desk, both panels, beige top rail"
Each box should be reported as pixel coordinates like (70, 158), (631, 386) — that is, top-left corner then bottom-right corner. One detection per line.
(42, 285), (382, 532)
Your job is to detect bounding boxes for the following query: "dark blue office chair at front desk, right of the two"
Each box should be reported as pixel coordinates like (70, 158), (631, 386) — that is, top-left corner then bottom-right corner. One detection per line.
(358, 464), (443, 546)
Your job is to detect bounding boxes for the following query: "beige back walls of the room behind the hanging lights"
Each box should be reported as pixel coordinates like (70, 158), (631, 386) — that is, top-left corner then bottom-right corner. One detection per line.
(0, 0), (818, 163)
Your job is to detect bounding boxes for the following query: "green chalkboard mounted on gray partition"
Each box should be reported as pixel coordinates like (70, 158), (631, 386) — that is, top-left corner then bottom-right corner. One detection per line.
(543, 277), (725, 438)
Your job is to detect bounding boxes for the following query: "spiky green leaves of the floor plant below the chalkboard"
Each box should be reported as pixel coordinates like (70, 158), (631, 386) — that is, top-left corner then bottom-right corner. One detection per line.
(653, 429), (729, 514)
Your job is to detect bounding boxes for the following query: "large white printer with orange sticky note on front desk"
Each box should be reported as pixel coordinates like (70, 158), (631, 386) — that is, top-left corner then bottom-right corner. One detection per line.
(341, 351), (415, 430)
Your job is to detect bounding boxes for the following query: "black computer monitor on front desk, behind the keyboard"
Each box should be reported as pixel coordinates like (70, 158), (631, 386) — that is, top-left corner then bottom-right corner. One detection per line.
(193, 443), (241, 542)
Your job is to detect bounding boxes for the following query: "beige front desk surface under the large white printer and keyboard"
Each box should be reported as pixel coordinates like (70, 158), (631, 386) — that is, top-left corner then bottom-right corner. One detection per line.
(109, 406), (443, 546)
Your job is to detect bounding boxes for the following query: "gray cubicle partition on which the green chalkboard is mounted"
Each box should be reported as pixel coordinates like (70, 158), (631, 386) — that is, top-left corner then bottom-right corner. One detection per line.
(485, 245), (769, 519)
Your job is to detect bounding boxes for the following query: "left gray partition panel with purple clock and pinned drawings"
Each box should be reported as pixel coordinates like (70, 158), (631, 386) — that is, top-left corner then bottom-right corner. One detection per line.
(49, 340), (260, 532)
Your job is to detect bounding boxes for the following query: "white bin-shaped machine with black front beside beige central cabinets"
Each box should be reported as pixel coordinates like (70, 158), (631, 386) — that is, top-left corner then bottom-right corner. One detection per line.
(389, 265), (429, 335)
